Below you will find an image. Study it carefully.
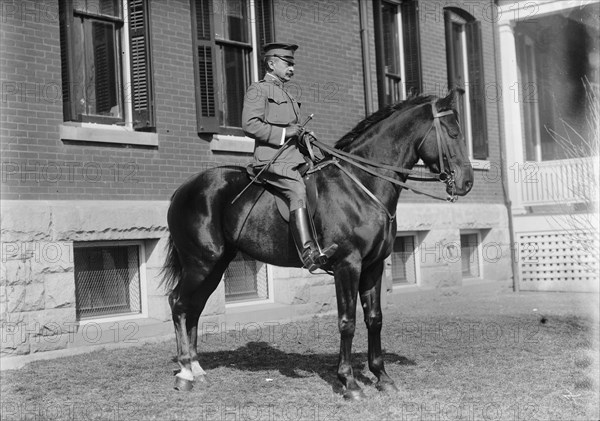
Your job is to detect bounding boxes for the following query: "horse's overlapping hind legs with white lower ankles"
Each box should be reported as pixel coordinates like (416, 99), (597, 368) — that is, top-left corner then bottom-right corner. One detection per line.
(169, 251), (235, 390)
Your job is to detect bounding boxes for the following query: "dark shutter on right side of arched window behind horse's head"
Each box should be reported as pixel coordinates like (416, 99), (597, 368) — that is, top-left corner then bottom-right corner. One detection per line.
(465, 21), (488, 159)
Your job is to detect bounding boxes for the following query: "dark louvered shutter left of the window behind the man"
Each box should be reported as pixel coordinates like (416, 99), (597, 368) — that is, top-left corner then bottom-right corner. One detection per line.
(191, 0), (219, 133)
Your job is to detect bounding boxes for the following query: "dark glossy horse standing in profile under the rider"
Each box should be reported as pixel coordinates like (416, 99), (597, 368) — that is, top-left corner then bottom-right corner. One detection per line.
(164, 92), (473, 399)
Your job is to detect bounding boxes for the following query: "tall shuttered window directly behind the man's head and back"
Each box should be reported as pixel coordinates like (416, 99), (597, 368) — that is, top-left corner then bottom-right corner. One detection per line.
(191, 0), (275, 134)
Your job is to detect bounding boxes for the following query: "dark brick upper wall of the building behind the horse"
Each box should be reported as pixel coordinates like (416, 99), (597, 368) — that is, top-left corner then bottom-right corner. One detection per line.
(0, 0), (502, 203)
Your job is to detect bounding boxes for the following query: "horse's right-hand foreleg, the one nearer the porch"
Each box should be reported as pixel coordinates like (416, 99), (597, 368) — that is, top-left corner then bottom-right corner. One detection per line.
(359, 261), (398, 391)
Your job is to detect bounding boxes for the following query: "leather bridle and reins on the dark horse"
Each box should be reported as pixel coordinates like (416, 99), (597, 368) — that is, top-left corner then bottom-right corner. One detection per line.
(306, 101), (458, 221)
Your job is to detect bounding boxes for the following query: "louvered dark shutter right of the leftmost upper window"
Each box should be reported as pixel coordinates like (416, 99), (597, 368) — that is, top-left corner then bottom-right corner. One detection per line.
(128, 0), (155, 130)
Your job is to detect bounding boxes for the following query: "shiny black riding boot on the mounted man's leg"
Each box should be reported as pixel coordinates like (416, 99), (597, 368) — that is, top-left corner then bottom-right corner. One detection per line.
(290, 208), (337, 272)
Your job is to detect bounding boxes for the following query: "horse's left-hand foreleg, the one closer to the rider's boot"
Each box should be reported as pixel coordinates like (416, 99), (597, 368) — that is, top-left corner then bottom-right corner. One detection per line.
(335, 260), (365, 400)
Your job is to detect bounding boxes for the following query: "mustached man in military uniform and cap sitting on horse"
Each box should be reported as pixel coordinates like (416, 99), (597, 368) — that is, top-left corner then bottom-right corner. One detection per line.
(242, 43), (337, 272)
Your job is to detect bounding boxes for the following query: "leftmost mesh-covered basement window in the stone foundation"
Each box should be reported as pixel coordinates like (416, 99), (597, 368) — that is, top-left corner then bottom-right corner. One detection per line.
(73, 244), (143, 320)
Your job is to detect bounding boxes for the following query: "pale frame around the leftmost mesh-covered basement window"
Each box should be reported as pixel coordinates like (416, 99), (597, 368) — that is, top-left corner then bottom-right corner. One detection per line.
(73, 240), (148, 326)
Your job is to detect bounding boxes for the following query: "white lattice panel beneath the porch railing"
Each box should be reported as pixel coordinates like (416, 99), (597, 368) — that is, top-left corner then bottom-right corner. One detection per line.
(518, 230), (598, 291)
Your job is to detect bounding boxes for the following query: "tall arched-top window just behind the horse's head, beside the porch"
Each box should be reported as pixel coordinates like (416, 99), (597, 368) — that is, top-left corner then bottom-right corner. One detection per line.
(444, 8), (488, 159)
